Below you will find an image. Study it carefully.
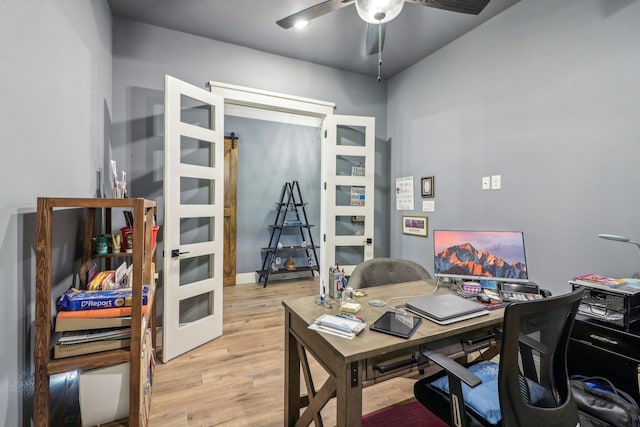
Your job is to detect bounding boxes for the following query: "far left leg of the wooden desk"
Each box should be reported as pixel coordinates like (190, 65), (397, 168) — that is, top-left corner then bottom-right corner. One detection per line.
(284, 311), (300, 426)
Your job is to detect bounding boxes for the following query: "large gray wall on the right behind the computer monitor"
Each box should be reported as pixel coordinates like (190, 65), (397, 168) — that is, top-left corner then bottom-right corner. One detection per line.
(388, 0), (640, 292)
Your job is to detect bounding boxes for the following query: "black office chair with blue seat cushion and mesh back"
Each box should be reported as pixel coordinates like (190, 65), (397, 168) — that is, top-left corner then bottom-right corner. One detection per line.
(414, 289), (583, 427)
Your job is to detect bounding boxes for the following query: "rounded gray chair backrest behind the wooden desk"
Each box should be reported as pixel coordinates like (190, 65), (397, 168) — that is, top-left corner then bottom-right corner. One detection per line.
(348, 258), (431, 289)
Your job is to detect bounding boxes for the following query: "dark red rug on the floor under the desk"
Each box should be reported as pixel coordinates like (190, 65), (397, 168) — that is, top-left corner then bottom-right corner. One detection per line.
(362, 401), (448, 427)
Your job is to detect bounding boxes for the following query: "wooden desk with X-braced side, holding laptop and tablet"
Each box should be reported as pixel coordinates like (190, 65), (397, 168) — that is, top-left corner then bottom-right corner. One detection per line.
(282, 281), (504, 427)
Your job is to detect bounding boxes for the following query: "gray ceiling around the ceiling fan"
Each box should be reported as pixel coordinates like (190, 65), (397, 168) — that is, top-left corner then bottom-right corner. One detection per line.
(108, 0), (520, 78)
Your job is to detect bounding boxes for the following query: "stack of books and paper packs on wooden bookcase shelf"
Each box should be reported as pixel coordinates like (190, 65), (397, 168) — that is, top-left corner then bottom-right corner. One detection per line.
(53, 286), (152, 359)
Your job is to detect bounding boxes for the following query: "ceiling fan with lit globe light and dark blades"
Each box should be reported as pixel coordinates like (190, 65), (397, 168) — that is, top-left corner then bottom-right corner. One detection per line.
(276, 0), (490, 55)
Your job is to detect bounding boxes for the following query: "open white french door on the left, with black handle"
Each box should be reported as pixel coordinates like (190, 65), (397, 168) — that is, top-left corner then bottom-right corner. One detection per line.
(162, 76), (224, 363)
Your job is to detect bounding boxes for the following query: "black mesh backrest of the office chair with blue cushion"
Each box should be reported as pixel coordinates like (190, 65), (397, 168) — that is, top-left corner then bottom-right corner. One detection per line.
(498, 289), (583, 427)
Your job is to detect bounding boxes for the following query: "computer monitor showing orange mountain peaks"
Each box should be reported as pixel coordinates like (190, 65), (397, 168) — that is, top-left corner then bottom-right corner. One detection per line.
(433, 230), (529, 283)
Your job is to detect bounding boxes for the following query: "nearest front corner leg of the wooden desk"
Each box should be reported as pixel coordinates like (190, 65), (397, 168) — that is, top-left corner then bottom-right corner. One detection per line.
(336, 362), (364, 427)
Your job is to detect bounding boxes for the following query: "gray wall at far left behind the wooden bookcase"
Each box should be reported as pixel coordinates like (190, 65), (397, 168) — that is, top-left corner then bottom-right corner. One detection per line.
(0, 0), (112, 426)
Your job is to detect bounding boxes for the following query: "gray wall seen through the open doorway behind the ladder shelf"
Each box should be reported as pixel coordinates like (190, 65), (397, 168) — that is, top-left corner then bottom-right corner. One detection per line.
(224, 116), (320, 273)
